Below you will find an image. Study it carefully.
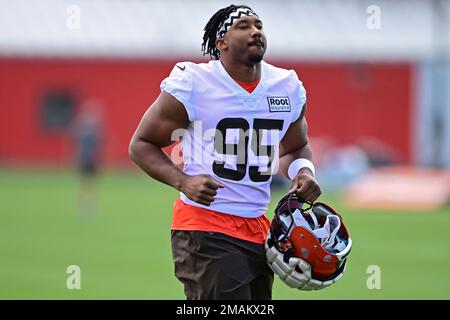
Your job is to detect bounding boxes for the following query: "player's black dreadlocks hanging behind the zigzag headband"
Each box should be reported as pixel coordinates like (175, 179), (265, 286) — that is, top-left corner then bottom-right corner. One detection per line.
(202, 4), (251, 60)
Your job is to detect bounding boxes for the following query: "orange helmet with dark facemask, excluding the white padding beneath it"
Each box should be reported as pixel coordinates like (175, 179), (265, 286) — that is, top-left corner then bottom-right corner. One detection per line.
(268, 193), (352, 281)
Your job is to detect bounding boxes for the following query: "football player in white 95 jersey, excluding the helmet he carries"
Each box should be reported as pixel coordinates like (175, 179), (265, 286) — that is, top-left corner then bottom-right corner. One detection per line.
(130, 5), (321, 299)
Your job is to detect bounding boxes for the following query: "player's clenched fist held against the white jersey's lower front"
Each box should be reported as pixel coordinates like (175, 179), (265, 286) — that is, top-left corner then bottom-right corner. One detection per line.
(180, 174), (225, 206)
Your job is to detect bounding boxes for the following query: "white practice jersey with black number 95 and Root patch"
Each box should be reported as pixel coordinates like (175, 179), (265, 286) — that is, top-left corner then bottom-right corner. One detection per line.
(161, 60), (306, 218)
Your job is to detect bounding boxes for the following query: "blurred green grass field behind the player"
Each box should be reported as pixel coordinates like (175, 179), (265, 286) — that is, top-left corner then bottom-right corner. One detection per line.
(0, 170), (450, 299)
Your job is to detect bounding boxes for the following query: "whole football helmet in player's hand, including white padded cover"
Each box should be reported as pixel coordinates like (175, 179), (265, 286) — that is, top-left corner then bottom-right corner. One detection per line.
(265, 193), (352, 290)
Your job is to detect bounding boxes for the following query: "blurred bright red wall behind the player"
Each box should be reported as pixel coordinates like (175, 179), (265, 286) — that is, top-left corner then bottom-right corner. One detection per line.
(0, 58), (412, 163)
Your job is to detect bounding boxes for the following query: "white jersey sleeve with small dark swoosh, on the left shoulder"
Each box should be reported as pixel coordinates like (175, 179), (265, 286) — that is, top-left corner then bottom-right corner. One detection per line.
(160, 62), (195, 122)
